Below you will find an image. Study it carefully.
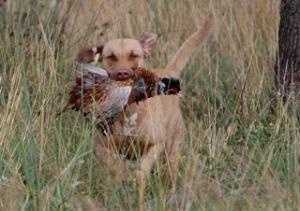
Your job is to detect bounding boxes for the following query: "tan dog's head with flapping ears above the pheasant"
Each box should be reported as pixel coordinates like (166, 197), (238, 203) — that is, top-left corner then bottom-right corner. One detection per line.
(77, 33), (157, 79)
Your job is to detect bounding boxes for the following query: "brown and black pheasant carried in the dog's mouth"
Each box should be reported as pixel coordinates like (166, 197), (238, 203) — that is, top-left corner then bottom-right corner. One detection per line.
(64, 64), (180, 129)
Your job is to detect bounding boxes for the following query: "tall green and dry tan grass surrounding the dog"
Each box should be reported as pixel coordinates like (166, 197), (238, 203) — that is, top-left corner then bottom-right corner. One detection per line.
(0, 0), (300, 210)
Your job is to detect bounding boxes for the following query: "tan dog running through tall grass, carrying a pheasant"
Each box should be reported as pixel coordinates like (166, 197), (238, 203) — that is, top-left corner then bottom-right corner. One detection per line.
(77, 17), (212, 186)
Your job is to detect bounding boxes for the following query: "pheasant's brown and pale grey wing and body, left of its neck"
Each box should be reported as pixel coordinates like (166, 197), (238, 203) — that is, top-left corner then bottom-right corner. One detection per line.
(66, 65), (133, 122)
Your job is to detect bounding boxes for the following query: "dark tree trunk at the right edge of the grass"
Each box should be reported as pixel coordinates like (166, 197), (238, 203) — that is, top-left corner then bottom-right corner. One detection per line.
(275, 0), (300, 101)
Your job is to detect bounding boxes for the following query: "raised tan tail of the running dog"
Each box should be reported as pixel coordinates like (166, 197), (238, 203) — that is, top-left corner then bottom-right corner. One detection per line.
(166, 16), (213, 77)
